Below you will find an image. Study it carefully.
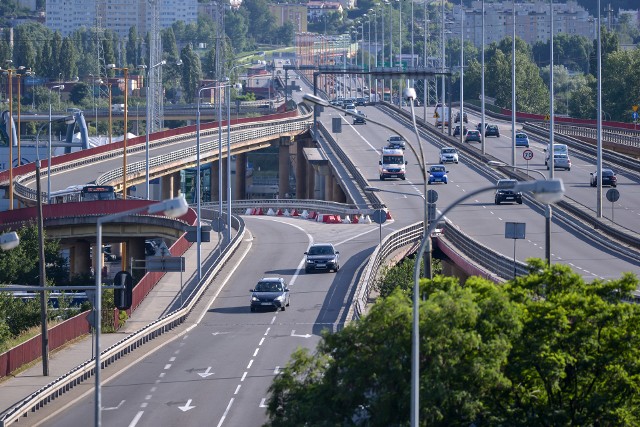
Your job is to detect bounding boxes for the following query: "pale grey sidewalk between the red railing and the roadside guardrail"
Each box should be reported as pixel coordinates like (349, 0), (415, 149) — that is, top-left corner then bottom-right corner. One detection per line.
(0, 233), (218, 413)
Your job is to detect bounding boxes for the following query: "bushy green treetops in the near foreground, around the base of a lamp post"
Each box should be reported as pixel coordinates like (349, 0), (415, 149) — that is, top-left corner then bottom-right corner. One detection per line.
(267, 260), (640, 426)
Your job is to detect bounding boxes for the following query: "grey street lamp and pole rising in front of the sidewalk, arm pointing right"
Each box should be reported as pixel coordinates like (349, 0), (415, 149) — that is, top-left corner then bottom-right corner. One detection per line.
(93, 196), (189, 427)
